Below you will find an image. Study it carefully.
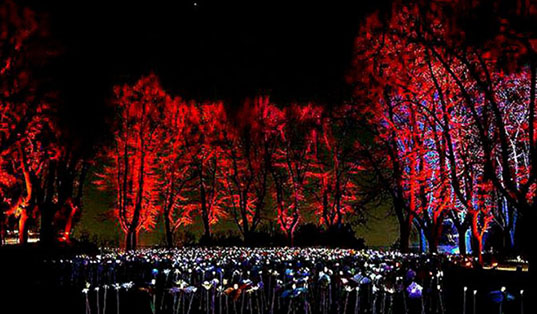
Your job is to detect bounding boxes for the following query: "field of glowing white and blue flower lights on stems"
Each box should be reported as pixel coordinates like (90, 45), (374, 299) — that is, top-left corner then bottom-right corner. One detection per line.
(33, 247), (524, 314)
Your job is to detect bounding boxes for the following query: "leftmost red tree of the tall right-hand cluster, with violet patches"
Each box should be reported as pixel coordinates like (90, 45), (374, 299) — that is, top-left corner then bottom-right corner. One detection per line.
(355, 29), (449, 251)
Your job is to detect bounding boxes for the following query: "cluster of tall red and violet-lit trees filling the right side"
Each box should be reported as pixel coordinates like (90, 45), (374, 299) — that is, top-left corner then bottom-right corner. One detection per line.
(349, 1), (537, 260)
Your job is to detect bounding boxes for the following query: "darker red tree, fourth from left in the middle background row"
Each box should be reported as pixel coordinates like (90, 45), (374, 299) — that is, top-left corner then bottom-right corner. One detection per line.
(222, 96), (275, 241)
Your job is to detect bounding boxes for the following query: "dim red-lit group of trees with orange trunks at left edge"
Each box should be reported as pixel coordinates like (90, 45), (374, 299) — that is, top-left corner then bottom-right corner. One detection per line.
(0, 1), (91, 244)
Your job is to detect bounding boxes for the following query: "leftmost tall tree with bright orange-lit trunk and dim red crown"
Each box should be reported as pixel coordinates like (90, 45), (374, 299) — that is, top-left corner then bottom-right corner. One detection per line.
(0, 1), (58, 243)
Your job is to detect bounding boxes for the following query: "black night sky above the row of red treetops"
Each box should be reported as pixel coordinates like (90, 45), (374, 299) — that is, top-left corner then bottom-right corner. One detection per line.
(31, 0), (386, 106)
